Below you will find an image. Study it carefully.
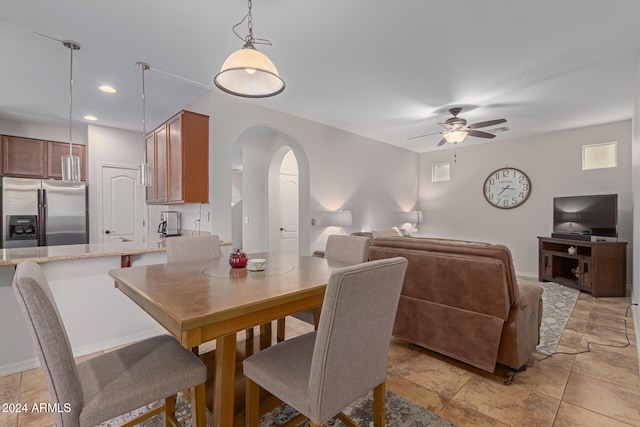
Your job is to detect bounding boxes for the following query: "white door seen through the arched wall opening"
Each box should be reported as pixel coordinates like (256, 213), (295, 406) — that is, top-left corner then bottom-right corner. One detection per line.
(280, 174), (298, 254)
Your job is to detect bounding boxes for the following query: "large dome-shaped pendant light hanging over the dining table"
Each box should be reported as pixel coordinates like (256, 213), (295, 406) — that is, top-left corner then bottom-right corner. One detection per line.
(214, 0), (284, 98)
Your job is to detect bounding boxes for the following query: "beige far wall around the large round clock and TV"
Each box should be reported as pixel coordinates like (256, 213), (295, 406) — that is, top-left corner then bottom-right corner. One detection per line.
(420, 120), (633, 274)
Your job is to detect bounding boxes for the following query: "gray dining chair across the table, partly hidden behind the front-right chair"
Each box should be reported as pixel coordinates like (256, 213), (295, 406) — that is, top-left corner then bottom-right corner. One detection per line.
(284, 234), (371, 334)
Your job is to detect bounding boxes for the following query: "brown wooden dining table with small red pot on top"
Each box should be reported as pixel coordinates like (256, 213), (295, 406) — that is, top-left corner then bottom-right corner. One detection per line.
(109, 252), (347, 427)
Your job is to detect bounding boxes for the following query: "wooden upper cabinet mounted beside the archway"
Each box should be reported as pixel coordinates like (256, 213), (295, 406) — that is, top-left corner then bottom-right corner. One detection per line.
(146, 111), (209, 204)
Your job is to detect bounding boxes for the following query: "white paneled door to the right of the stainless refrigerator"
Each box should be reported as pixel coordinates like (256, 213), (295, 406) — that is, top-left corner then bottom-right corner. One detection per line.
(100, 165), (145, 242)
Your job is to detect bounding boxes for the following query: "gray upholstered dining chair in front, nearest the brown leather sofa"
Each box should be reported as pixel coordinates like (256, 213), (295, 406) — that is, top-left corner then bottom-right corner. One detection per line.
(243, 257), (407, 427)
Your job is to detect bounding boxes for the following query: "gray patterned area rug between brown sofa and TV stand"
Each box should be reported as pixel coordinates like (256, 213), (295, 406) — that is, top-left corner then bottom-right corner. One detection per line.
(518, 277), (580, 354)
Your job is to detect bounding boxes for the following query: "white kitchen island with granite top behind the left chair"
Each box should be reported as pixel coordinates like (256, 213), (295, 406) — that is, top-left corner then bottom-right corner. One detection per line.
(0, 240), (166, 376)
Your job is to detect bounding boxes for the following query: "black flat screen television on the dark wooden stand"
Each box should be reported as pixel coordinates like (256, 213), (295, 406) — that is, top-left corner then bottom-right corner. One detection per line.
(553, 194), (618, 237)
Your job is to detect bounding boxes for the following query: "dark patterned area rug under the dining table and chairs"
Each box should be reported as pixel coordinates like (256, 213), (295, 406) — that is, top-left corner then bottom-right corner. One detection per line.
(101, 391), (456, 427)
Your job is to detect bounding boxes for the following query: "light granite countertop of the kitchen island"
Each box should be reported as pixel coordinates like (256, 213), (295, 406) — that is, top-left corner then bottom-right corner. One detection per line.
(0, 240), (165, 267)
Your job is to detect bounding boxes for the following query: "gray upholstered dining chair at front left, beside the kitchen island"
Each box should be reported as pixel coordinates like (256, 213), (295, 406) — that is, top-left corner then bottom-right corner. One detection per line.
(13, 261), (207, 427)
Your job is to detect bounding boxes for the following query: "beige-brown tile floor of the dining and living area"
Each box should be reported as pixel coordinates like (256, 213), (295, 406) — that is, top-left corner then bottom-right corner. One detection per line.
(0, 293), (640, 427)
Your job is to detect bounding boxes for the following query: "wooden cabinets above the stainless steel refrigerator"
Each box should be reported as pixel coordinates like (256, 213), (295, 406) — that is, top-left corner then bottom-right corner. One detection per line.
(0, 135), (86, 181)
